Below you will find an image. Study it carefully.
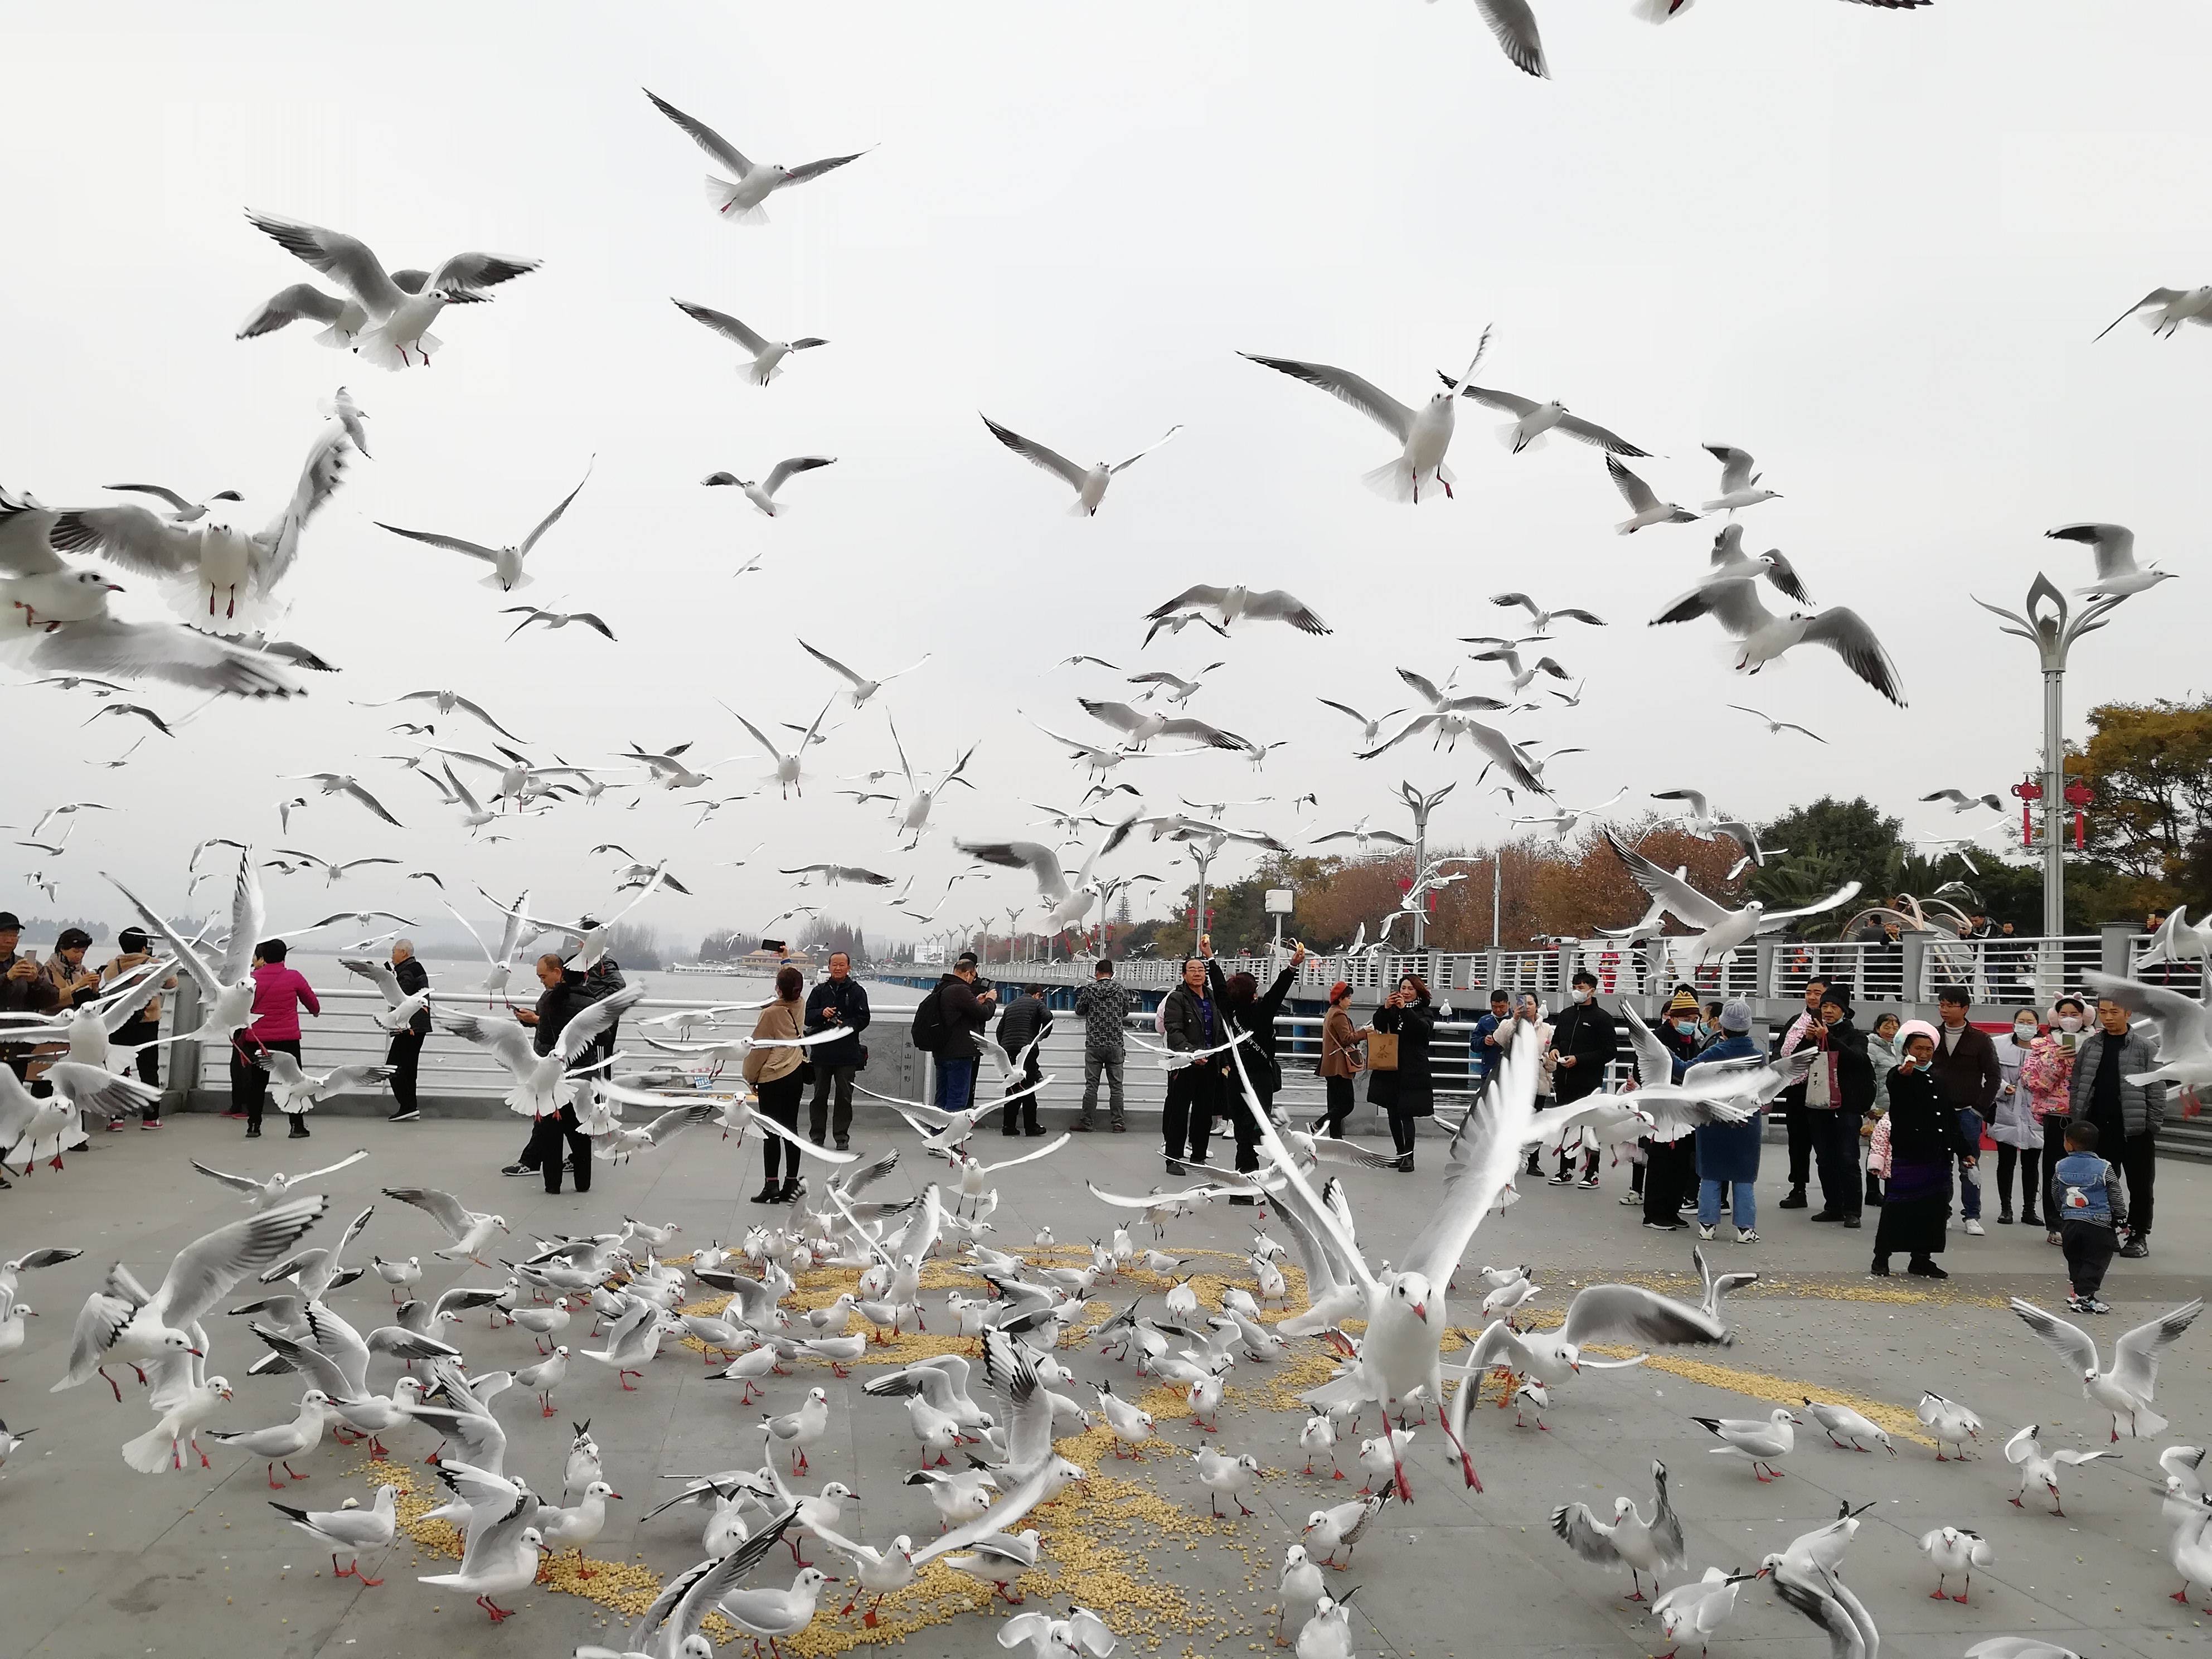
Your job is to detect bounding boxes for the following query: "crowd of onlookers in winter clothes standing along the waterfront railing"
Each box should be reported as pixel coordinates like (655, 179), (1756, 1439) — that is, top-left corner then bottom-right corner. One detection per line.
(0, 911), (2168, 1312)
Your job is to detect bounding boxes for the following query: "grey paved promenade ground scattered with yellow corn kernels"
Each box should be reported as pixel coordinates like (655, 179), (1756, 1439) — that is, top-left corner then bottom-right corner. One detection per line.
(0, 1115), (2212, 1659)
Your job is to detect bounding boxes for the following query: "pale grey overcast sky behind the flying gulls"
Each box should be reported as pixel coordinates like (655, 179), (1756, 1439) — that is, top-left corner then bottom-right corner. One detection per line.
(0, 0), (2212, 942)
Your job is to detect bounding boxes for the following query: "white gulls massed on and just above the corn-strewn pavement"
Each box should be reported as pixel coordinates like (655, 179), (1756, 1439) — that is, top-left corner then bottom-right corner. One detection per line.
(0, 1013), (2212, 1659)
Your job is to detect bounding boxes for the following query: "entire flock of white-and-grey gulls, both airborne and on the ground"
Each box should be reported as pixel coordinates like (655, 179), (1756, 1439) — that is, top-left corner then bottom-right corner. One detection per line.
(0, 13), (2212, 1659)
